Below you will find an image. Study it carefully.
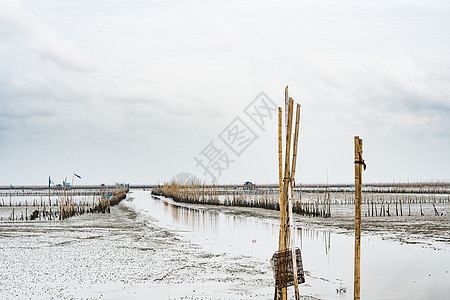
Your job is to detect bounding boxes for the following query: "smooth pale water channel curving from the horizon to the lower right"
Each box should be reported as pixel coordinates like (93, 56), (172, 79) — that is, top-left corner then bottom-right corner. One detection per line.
(133, 193), (450, 299)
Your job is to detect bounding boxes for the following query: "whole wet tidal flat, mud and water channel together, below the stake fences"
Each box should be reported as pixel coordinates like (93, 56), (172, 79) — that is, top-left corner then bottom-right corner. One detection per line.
(0, 190), (450, 299)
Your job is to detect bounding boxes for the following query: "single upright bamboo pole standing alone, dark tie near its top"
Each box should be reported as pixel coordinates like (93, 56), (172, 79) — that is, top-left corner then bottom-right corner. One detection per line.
(353, 136), (364, 300)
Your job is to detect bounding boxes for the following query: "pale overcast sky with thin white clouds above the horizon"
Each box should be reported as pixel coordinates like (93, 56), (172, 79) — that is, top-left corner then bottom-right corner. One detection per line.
(0, 0), (450, 185)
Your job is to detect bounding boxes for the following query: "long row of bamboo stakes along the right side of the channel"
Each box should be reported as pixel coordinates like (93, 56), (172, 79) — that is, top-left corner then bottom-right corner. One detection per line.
(152, 183), (450, 218)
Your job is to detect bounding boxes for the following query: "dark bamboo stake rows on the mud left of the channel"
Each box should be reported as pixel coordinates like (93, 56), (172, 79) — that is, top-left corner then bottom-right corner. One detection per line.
(2, 186), (129, 221)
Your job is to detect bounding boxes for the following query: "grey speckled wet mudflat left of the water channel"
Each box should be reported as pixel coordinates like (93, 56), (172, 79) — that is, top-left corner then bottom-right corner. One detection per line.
(0, 193), (290, 299)
